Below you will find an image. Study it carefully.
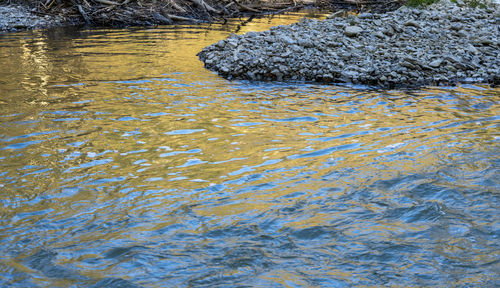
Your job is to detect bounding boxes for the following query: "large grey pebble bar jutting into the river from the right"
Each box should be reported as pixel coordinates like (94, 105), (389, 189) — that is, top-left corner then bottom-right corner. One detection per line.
(198, 1), (500, 87)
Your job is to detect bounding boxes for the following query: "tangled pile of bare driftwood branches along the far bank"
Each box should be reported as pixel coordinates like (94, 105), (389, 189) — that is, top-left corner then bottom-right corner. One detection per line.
(36, 0), (403, 26)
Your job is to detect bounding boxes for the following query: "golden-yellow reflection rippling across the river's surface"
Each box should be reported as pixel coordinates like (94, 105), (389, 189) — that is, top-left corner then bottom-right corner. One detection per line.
(0, 10), (500, 286)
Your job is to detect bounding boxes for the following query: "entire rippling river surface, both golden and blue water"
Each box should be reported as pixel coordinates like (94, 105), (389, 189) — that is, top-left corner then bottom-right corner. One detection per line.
(0, 14), (500, 287)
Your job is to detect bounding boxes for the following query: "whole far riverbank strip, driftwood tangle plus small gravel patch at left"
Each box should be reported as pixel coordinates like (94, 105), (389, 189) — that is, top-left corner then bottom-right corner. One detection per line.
(0, 0), (403, 32)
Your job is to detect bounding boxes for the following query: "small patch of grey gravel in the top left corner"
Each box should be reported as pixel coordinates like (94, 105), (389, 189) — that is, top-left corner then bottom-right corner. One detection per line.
(0, 5), (63, 31)
